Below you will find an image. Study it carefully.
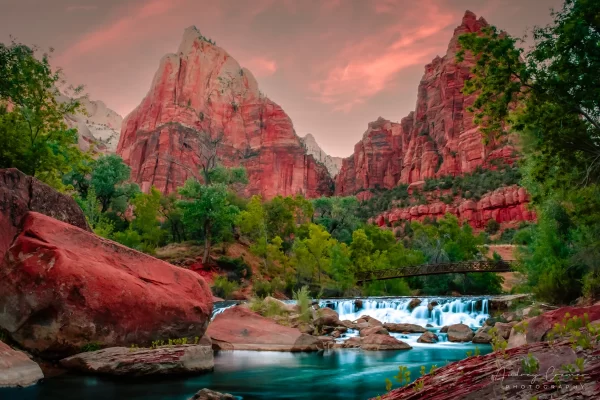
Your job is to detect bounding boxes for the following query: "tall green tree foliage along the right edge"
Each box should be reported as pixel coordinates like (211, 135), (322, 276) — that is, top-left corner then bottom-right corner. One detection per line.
(458, 0), (600, 303)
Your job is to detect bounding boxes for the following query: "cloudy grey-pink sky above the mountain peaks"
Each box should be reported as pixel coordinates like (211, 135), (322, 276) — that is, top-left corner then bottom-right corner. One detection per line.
(0, 0), (562, 156)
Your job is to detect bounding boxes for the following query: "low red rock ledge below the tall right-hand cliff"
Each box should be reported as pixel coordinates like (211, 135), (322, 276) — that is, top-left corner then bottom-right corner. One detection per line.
(375, 186), (536, 228)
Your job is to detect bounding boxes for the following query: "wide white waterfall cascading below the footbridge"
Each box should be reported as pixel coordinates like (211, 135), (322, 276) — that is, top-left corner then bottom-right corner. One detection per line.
(319, 297), (489, 328)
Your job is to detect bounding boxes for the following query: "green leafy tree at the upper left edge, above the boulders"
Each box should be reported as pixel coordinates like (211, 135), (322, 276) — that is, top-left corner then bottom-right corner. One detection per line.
(0, 41), (84, 189)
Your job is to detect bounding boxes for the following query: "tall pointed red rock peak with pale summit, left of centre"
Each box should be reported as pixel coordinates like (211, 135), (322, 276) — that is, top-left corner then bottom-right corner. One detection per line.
(117, 27), (333, 198)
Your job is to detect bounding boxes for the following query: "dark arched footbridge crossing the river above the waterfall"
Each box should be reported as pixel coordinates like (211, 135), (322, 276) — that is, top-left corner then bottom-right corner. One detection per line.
(356, 260), (511, 283)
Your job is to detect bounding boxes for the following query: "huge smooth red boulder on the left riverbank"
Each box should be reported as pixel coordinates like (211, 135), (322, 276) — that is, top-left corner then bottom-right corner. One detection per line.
(0, 212), (212, 358)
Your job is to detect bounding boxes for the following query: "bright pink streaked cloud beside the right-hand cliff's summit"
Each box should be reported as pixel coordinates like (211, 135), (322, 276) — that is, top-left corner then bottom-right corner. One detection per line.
(310, 0), (456, 112)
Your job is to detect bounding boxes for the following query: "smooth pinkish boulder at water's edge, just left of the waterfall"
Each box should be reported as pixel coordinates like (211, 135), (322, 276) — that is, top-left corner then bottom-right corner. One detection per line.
(207, 306), (323, 351)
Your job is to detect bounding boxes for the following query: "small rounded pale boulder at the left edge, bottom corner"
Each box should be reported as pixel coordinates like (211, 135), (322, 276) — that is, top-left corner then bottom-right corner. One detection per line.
(0, 342), (44, 388)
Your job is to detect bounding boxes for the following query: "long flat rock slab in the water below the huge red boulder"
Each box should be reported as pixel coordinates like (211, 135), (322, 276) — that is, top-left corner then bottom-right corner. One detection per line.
(60, 345), (214, 377)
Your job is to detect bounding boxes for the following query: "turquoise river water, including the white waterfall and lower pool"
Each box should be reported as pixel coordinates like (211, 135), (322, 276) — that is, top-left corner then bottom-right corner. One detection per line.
(0, 297), (491, 400)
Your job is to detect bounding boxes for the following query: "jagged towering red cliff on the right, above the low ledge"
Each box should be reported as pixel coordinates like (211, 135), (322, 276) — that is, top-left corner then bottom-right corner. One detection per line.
(335, 11), (514, 195)
